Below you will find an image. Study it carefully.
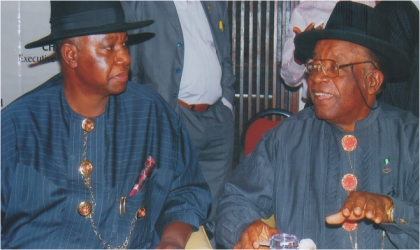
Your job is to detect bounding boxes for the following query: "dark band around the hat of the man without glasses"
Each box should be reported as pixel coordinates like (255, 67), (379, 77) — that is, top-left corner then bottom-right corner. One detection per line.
(50, 8), (124, 33)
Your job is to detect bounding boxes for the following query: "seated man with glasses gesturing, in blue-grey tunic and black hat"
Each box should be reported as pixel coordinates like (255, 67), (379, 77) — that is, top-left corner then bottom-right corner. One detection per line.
(216, 1), (419, 249)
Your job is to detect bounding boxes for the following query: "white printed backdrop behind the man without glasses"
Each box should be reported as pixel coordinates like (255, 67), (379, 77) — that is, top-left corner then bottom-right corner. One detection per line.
(0, 1), (59, 108)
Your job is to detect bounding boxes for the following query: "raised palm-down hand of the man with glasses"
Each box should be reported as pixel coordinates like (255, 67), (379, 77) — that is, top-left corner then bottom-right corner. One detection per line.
(325, 191), (393, 225)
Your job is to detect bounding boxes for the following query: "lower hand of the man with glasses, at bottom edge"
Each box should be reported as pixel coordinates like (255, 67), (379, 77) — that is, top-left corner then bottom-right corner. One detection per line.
(233, 220), (280, 249)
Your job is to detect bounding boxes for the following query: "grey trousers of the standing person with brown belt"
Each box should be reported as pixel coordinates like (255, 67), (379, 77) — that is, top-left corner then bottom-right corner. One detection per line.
(175, 101), (234, 248)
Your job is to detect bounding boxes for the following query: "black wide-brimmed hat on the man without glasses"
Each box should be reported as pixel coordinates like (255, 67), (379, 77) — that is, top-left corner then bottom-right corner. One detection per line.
(25, 1), (153, 49)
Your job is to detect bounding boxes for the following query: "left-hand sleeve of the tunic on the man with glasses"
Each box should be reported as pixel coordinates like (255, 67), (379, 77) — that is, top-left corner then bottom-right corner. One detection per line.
(216, 131), (274, 248)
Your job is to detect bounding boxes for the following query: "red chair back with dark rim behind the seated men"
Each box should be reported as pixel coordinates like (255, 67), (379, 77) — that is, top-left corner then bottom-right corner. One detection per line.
(241, 109), (292, 158)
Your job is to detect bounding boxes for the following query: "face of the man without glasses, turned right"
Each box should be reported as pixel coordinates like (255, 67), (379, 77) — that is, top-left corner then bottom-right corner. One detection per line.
(75, 32), (130, 96)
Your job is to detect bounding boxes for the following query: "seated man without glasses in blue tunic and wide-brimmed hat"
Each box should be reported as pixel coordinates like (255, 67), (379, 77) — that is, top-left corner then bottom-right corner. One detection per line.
(1, 1), (211, 248)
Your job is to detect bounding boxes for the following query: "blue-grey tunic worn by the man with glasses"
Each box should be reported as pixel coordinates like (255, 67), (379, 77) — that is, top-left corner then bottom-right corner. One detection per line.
(216, 104), (419, 249)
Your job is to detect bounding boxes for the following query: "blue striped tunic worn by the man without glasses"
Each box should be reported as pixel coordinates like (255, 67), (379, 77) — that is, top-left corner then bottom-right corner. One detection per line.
(1, 74), (211, 248)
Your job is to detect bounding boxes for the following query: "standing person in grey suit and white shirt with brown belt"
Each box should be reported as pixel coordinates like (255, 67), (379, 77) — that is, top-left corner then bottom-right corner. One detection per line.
(121, 1), (235, 247)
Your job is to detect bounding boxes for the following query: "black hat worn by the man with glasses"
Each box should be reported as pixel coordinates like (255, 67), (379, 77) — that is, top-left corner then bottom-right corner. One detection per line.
(294, 1), (410, 80)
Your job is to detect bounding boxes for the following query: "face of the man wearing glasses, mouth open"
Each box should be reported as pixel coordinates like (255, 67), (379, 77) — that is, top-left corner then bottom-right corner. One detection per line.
(308, 40), (373, 131)
